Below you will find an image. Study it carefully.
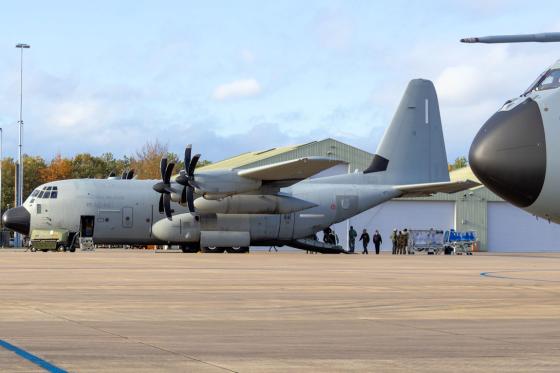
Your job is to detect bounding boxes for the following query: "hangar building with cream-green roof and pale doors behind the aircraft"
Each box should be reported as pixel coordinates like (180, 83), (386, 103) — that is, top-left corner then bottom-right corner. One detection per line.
(201, 139), (560, 252)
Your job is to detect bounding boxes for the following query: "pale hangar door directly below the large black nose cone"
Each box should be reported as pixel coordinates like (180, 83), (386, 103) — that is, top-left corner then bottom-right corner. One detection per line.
(488, 202), (560, 252)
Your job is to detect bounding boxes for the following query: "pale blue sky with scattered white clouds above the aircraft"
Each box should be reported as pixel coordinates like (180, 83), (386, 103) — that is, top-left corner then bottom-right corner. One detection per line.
(0, 0), (560, 161)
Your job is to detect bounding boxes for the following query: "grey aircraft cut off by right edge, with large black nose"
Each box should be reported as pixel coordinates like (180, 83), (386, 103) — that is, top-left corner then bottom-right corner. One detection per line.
(461, 32), (560, 223)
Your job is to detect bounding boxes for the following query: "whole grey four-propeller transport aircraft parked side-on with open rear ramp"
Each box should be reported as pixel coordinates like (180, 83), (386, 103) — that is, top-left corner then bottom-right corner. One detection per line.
(3, 79), (477, 252)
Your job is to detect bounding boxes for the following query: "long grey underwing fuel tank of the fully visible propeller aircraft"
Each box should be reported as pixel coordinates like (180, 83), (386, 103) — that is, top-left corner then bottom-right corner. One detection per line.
(194, 194), (317, 214)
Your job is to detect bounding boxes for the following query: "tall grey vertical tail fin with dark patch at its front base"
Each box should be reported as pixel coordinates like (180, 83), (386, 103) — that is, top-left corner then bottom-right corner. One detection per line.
(364, 79), (449, 185)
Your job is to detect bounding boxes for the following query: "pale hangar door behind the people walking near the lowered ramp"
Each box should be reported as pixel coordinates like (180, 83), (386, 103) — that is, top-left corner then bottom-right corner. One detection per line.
(332, 200), (455, 251)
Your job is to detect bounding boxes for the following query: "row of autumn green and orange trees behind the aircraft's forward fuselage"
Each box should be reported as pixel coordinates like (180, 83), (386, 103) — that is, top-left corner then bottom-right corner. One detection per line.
(1, 140), (211, 212)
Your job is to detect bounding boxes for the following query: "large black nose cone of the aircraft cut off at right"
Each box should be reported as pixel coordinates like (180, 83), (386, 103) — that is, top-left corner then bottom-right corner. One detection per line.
(469, 99), (546, 207)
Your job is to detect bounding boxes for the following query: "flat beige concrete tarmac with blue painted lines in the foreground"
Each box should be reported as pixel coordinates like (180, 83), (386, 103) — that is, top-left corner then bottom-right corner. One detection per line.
(0, 250), (560, 373)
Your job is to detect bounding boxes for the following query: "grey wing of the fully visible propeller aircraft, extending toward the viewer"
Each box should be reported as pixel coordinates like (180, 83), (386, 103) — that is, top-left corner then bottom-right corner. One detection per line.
(238, 157), (345, 182)
